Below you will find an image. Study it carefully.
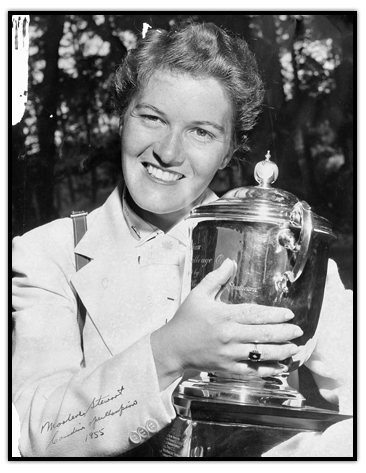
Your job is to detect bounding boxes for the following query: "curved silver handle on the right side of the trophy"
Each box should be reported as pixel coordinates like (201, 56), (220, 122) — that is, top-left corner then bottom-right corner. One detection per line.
(276, 200), (314, 293)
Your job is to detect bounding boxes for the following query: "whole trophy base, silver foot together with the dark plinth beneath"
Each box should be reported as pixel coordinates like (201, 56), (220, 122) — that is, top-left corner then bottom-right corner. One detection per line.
(117, 374), (351, 458)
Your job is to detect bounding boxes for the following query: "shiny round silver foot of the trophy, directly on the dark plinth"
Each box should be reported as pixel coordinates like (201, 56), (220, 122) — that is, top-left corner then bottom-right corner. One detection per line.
(179, 374), (306, 408)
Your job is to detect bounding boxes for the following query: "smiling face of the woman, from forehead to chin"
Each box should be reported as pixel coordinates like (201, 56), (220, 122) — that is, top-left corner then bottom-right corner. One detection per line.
(122, 71), (233, 228)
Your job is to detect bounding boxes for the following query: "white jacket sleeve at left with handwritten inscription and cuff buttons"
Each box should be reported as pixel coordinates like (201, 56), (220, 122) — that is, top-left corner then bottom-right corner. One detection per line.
(13, 224), (178, 457)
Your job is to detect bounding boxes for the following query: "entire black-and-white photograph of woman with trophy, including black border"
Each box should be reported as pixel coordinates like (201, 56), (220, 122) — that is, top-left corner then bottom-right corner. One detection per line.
(7, 9), (358, 458)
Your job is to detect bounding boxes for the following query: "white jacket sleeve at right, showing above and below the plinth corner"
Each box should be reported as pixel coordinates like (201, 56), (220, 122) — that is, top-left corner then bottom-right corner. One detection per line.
(262, 261), (353, 458)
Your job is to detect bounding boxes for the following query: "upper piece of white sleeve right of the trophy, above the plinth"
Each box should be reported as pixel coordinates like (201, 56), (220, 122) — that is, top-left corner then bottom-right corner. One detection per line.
(305, 260), (353, 414)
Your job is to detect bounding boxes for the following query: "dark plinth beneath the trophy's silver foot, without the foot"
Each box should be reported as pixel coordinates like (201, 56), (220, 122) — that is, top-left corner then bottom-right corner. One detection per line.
(159, 394), (351, 458)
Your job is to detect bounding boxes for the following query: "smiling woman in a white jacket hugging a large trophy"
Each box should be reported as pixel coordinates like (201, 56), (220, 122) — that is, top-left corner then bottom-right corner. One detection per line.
(13, 19), (349, 457)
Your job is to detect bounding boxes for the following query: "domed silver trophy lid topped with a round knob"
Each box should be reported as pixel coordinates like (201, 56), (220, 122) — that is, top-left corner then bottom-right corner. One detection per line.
(189, 151), (334, 236)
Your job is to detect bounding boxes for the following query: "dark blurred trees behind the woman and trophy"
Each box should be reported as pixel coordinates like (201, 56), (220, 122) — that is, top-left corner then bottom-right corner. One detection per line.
(12, 12), (356, 288)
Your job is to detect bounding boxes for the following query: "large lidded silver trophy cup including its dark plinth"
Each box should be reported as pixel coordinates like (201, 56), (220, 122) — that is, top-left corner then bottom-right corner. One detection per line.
(160, 152), (352, 457)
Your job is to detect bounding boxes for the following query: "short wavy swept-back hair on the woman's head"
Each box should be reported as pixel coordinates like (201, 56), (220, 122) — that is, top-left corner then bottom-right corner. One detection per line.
(114, 23), (264, 151)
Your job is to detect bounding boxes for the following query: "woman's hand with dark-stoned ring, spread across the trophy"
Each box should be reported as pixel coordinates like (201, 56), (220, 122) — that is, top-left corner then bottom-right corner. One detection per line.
(151, 259), (303, 389)
